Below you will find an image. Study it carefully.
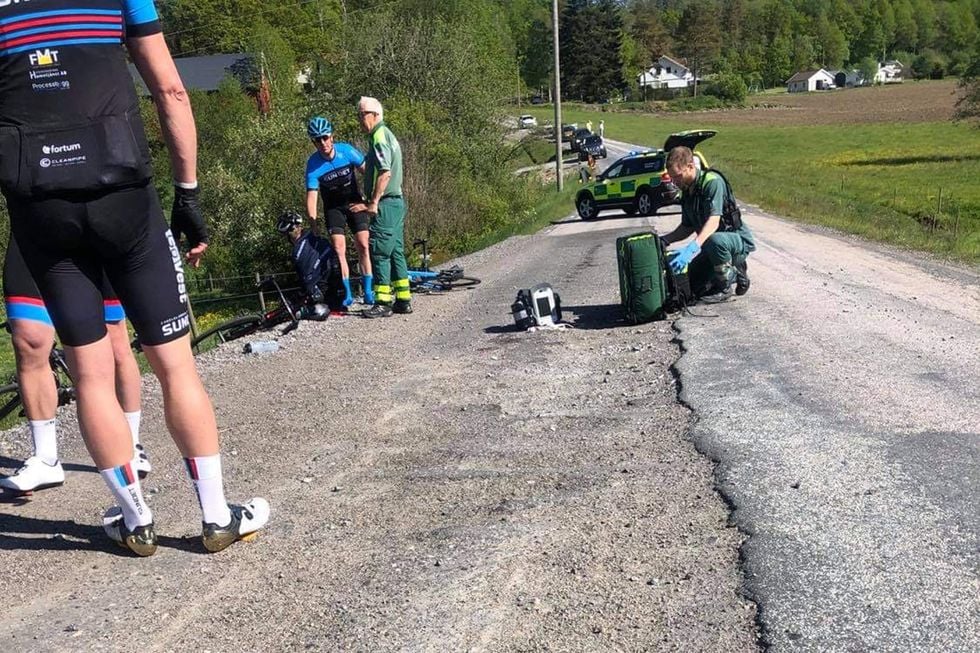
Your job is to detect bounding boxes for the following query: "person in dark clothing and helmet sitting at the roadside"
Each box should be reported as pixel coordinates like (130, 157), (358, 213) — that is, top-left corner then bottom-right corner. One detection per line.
(276, 209), (345, 320)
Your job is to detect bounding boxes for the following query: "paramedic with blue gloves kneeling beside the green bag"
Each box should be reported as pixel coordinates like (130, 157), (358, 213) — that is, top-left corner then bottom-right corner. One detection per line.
(662, 146), (755, 299)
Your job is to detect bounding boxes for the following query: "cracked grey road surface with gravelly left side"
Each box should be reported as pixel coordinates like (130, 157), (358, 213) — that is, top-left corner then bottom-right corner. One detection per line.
(0, 181), (980, 653)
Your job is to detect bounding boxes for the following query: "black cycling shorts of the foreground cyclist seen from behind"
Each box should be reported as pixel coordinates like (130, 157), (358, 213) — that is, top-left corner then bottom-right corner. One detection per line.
(7, 184), (190, 347)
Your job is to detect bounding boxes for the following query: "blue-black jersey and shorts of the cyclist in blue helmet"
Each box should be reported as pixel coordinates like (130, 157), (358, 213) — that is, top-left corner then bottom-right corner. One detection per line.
(306, 142), (371, 234)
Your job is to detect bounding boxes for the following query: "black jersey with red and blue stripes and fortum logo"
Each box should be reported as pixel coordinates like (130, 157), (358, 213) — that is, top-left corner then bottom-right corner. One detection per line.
(0, 0), (161, 196)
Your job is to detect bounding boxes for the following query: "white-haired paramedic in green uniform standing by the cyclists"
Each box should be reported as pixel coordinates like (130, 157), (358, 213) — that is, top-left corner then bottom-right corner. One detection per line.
(357, 97), (412, 318)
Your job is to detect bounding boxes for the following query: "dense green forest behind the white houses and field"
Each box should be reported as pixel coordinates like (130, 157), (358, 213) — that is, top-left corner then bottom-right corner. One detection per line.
(511, 0), (980, 101)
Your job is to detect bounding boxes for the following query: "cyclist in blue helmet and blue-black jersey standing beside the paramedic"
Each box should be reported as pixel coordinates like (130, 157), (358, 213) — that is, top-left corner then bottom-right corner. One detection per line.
(306, 116), (374, 306)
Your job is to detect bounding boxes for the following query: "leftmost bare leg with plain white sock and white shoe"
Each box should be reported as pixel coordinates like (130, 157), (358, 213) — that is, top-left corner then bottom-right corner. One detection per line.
(0, 319), (65, 493)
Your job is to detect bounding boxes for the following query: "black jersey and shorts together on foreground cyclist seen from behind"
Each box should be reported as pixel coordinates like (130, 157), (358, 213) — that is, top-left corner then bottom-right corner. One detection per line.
(0, 0), (189, 346)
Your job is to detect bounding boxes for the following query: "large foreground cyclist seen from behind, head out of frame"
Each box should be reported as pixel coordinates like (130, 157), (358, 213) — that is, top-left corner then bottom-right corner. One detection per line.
(0, 0), (269, 556)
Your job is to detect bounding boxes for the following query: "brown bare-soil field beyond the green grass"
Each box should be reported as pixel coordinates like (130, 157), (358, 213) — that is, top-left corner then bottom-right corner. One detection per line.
(672, 80), (959, 125)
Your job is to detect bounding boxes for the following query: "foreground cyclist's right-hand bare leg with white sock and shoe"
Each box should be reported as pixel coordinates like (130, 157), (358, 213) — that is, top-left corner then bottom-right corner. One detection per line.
(143, 336), (269, 551)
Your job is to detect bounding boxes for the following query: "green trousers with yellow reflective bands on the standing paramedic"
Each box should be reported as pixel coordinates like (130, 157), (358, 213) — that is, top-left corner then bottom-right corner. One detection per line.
(370, 197), (411, 304)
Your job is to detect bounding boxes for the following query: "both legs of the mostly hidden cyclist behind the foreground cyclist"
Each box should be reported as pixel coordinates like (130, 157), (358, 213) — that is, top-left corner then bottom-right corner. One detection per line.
(0, 239), (151, 494)
